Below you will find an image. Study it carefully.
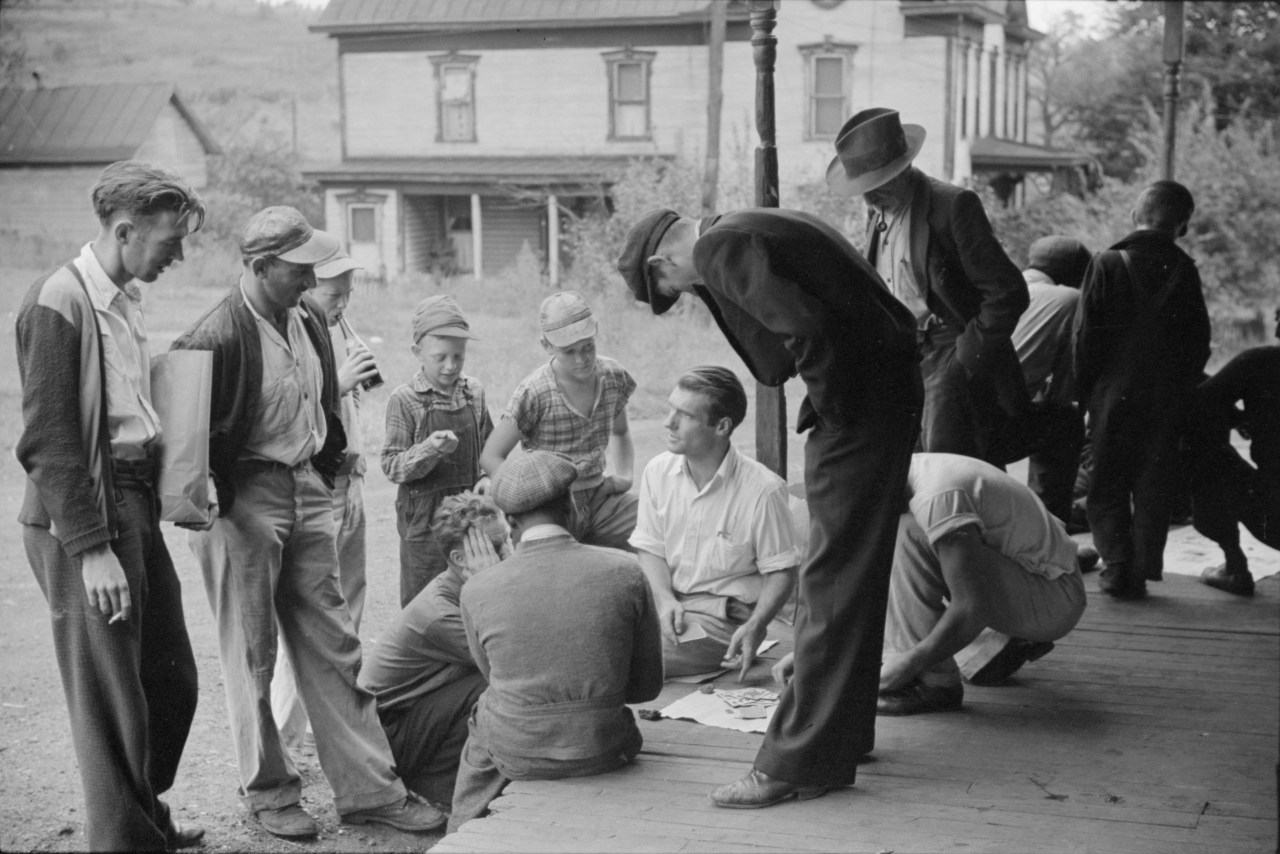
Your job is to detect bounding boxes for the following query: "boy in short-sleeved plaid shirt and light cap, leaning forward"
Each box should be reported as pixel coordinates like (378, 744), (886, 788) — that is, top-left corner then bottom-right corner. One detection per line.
(480, 291), (637, 552)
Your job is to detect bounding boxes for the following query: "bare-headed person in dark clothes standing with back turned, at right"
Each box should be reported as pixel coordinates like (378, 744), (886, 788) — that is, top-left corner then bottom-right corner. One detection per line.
(1074, 181), (1210, 599)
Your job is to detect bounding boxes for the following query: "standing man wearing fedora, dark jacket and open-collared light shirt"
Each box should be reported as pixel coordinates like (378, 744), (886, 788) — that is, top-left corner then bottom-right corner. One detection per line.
(827, 108), (1029, 466)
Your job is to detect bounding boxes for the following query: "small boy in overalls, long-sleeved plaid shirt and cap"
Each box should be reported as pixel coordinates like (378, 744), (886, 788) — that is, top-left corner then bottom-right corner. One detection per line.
(381, 294), (493, 608)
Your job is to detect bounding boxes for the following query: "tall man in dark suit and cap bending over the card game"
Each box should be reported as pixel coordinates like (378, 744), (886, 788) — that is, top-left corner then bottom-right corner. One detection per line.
(618, 209), (923, 809)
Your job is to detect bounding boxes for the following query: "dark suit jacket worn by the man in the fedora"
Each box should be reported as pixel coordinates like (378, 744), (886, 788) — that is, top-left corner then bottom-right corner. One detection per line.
(867, 168), (1029, 414)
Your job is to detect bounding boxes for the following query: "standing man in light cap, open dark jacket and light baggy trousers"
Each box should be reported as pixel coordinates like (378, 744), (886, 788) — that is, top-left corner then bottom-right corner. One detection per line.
(174, 206), (444, 839)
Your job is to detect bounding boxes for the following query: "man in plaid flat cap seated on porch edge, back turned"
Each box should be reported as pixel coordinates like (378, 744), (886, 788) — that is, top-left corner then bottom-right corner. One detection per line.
(449, 451), (662, 832)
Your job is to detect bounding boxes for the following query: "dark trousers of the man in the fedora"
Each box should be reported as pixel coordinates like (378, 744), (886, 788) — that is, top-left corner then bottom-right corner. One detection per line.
(920, 330), (1009, 469)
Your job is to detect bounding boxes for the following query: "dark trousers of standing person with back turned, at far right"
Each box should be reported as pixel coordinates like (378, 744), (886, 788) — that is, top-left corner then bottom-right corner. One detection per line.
(1088, 392), (1180, 583)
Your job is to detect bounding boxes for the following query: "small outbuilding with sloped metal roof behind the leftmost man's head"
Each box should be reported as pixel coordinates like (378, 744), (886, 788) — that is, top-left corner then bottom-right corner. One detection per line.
(0, 83), (221, 246)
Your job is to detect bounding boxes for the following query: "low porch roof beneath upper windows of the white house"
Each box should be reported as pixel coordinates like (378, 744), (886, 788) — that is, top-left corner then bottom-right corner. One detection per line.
(305, 155), (655, 184)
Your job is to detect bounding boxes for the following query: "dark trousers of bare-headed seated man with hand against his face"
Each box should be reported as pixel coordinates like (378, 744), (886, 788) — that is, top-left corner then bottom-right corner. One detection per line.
(379, 672), (485, 808)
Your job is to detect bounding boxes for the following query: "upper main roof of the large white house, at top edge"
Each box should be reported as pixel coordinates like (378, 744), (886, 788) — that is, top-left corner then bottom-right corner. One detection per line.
(311, 0), (741, 33)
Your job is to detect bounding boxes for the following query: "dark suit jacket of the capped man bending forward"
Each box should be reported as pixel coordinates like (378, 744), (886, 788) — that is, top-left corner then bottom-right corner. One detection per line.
(694, 207), (920, 431)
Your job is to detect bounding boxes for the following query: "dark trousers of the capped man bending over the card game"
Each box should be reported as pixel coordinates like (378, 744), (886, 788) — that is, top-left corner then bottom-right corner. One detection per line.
(755, 410), (919, 786)
